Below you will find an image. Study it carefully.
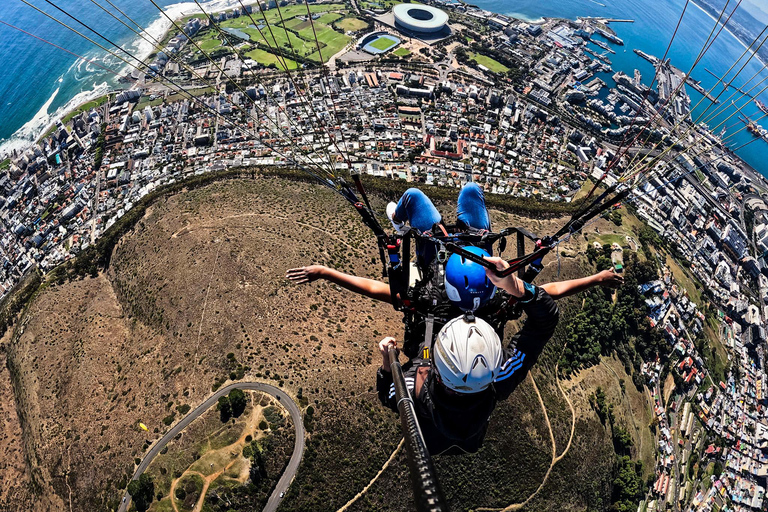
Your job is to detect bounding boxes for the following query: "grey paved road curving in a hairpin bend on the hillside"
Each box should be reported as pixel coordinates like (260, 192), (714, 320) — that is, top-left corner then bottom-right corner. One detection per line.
(117, 382), (304, 512)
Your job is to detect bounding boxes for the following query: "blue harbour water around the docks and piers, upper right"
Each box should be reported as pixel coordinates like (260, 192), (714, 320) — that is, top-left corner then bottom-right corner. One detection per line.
(472, 0), (768, 177)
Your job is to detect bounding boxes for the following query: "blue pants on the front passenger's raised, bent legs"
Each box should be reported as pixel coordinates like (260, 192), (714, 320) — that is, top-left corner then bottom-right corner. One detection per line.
(395, 183), (491, 265)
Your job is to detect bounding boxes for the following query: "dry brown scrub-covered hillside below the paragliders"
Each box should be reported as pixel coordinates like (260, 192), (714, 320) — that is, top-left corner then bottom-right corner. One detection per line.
(0, 178), (648, 510)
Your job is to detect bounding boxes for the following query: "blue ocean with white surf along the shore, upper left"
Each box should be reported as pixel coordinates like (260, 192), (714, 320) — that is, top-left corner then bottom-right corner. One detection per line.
(0, 0), (252, 159)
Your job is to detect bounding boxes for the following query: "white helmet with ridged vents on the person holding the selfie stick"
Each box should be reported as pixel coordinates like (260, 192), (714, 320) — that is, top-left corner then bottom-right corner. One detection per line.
(432, 316), (502, 393)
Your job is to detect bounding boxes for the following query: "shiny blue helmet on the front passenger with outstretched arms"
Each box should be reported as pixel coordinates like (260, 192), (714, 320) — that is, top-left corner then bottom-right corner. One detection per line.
(445, 246), (496, 311)
